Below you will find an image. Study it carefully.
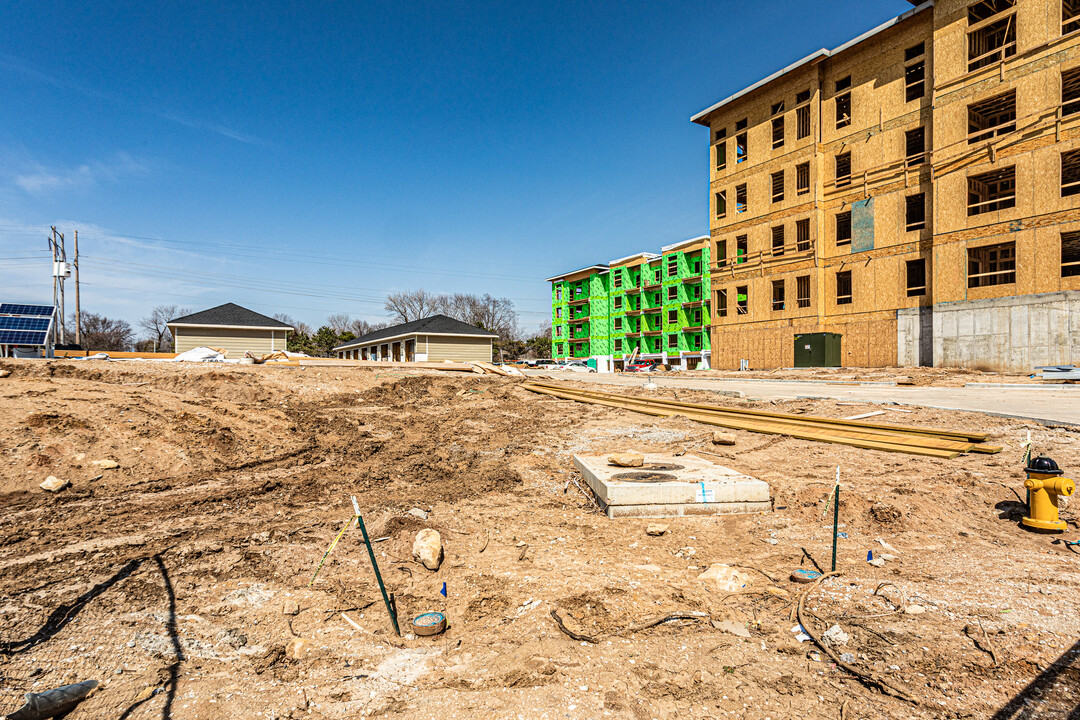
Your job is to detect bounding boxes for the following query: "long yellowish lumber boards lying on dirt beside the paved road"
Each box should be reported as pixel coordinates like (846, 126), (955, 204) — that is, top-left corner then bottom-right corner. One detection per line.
(522, 382), (1001, 458)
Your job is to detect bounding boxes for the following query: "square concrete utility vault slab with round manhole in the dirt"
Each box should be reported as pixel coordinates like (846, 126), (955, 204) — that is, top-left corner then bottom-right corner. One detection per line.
(573, 453), (771, 518)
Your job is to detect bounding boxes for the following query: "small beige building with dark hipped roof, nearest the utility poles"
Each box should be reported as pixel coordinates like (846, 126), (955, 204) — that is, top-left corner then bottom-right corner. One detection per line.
(166, 302), (293, 357)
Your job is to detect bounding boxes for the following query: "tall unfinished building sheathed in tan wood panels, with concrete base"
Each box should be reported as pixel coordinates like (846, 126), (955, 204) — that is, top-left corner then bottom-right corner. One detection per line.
(692, 0), (1080, 370)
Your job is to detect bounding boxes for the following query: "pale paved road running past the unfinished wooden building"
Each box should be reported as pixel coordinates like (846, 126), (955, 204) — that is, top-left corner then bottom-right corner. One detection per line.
(528, 371), (1080, 425)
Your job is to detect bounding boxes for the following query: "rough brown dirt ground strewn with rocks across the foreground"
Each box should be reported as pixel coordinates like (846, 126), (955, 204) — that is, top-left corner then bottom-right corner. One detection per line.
(0, 361), (1080, 720)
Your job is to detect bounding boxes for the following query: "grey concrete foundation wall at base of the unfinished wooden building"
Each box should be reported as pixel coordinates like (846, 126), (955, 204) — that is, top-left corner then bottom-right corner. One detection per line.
(896, 290), (1080, 372)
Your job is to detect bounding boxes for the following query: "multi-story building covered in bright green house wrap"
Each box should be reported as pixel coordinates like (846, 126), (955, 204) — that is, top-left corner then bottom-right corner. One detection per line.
(548, 236), (712, 372)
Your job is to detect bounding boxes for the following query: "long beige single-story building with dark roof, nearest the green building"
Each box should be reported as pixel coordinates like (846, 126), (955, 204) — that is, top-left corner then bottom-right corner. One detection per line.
(334, 315), (499, 363)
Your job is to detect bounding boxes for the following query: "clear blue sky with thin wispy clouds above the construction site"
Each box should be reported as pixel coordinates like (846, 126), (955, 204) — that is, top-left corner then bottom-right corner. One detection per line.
(0, 0), (912, 330)
